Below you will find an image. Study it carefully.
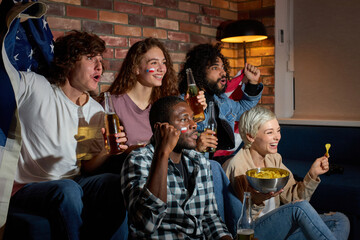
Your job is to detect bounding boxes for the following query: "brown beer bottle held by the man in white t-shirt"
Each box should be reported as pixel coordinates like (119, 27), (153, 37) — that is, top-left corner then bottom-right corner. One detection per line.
(104, 92), (122, 154)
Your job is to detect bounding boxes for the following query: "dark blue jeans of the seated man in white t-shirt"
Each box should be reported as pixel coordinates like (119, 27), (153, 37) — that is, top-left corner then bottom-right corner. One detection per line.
(10, 173), (126, 240)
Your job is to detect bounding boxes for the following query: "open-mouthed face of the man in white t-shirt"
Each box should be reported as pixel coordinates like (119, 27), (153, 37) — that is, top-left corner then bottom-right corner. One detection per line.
(67, 55), (103, 92)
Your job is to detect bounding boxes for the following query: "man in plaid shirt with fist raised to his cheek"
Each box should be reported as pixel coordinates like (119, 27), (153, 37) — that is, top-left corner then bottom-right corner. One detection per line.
(121, 96), (232, 239)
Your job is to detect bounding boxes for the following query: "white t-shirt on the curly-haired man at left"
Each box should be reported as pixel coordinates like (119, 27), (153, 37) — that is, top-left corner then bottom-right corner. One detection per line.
(15, 72), (104, 183)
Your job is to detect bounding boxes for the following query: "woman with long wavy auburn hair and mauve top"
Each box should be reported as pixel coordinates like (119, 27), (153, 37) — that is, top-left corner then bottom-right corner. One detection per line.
(101, 38), (206, 151)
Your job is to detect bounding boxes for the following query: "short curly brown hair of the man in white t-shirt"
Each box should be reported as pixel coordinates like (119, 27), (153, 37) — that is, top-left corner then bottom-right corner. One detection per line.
(45, 30), (106, 86)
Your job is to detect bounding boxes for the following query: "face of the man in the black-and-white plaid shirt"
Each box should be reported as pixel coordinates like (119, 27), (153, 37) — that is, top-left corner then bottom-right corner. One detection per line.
(169, 102), (197, 152)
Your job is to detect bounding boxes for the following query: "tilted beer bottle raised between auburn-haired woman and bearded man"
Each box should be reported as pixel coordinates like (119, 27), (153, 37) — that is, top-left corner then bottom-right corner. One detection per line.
(186, 68), (205, 122)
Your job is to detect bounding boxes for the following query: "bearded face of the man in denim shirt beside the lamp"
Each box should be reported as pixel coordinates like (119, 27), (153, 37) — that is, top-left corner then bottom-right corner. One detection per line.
(206, 57), (227, 95)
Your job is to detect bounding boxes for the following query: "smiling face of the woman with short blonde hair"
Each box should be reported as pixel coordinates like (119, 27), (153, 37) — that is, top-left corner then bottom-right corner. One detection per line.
(247, 118), (281, 157)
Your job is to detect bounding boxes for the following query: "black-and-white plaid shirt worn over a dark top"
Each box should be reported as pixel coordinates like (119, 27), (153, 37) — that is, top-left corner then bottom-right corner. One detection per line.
(121, 144), (231, 239)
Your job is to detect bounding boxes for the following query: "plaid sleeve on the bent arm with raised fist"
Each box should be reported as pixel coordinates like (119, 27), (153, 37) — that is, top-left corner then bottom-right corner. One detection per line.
(121, 147), (167, 234)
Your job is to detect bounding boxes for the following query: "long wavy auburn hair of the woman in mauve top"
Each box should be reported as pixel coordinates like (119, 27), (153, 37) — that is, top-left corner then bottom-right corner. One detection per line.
(100, 38), (179, 104)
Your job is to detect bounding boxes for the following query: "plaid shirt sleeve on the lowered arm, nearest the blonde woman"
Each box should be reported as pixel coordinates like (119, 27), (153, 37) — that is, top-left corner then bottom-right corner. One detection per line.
(203, 160), (232, 239)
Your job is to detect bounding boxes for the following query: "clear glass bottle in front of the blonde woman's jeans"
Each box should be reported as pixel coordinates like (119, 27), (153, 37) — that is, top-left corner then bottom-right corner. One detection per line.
(236, 192), (255, 240)
